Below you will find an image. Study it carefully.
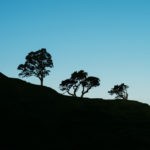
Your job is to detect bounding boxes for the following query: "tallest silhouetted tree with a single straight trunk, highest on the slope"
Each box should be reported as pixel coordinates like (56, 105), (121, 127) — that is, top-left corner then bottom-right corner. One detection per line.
(18, 48), (53, 86)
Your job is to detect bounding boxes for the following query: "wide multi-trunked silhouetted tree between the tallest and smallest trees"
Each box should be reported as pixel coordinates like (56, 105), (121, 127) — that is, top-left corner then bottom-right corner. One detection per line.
(60, 70), (100, 97)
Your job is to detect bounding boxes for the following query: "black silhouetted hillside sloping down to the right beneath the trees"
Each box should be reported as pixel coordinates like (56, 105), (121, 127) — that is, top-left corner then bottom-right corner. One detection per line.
(0, 73), (150, 150)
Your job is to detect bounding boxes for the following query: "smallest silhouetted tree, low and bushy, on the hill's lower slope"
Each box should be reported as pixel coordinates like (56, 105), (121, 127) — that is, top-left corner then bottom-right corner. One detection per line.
(108, 83), (129, 100)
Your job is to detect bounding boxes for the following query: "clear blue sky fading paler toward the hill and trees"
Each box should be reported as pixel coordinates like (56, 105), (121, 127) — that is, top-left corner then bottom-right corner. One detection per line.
(0, 0), (150, 104)
